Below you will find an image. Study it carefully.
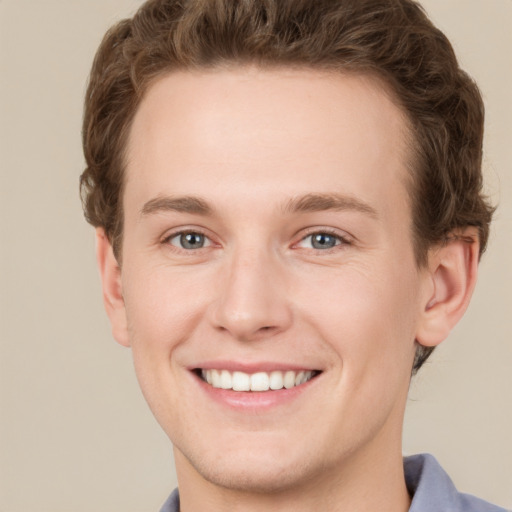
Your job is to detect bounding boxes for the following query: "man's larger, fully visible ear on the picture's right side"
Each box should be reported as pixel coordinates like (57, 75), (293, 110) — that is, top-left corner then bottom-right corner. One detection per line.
(416, 228), (479, 347)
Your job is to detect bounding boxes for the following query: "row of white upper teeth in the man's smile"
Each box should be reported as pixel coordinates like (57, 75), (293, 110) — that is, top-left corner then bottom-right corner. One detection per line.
(201, 370), (314, 391)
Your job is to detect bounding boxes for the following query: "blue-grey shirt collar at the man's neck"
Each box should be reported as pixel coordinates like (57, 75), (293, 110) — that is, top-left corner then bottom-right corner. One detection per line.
(160, 454), (512, 512)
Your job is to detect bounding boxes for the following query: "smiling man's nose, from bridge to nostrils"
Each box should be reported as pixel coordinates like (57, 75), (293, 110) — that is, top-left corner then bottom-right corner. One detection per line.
(212, 246), (292, 341)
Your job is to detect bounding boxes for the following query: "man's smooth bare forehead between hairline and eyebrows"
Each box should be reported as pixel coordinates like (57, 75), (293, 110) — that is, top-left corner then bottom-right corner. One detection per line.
(125, 68), (408, 220)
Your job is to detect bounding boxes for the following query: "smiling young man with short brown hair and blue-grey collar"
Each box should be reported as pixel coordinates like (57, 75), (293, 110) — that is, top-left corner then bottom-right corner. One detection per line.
(81, 0), (500, 512)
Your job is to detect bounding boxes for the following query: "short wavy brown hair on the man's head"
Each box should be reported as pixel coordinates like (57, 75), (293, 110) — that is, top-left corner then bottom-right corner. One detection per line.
(80, 0), (493, 371)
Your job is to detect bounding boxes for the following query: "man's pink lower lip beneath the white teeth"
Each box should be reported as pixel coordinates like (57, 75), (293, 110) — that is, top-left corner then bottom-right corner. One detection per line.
(194, 375), (319, 412)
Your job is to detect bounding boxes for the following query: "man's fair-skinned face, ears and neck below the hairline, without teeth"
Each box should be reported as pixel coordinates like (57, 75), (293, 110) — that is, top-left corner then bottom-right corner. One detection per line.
(97, 68), (478, 512)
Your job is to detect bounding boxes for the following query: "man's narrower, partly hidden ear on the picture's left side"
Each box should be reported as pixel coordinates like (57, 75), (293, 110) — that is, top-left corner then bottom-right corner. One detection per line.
(96, 228), (130, 347)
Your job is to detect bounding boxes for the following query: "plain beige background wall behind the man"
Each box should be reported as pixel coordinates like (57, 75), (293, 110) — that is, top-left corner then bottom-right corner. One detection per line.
(0, 0), (512, 512)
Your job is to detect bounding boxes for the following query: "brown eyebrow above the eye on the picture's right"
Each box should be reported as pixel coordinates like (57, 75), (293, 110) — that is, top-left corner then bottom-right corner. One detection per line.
(284, 194), (378, 218)
